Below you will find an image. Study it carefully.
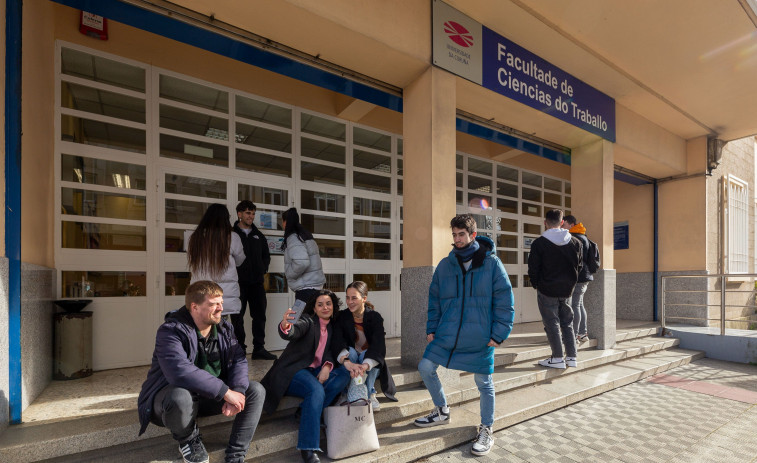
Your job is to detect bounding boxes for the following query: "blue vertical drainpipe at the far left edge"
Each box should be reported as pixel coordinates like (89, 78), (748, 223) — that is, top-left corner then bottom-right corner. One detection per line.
(5, 0), (23, 424)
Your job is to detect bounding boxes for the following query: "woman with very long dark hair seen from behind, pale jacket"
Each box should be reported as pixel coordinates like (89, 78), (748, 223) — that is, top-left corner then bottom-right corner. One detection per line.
(185, 204), (245, 315)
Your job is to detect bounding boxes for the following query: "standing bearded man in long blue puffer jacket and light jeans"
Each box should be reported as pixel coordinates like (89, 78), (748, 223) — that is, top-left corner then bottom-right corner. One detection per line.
(415, 214), (515, 455)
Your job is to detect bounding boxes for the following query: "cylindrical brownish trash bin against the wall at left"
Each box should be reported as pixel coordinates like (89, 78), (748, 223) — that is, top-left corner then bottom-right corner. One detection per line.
(53, 301), (92, 380)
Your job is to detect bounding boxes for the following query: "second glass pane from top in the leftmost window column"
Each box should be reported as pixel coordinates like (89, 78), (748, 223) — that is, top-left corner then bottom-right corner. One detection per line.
(60, 82), (145, 124)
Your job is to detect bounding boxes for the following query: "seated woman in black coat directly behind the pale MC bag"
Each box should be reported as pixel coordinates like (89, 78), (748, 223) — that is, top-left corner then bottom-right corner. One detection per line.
(331, 281), (397, 410)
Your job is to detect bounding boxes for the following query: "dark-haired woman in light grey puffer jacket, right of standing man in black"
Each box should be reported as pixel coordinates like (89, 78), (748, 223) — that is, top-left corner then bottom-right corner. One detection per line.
(281, 208), (326, 303)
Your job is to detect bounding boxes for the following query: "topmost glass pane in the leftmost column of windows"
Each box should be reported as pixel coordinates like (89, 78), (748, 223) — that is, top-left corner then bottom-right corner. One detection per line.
(61, 48), (145, 93)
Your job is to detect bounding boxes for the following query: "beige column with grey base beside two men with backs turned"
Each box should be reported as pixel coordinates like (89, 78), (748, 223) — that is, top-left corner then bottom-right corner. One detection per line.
(570, 140), (615, 349)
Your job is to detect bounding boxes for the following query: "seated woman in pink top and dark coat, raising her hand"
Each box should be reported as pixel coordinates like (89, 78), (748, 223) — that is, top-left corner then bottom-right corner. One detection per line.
(261, 289), (350, 463)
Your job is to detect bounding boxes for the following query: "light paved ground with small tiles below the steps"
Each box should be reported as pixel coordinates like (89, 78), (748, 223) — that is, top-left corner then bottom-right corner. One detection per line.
(419, 359), (757, 463)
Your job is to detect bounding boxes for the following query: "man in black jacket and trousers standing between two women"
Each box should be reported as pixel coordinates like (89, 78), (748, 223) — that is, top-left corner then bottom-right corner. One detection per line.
(231, 199), (276, 360)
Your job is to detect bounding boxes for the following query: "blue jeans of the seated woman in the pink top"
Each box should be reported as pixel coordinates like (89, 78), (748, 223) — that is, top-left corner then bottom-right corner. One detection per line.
(286, 365), (350, 451)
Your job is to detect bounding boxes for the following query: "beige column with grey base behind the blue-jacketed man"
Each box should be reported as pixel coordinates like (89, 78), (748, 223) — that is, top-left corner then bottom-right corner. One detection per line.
(401, 67), (456, 368)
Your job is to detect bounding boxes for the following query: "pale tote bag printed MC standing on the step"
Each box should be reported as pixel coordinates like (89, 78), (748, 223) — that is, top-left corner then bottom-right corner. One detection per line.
(323, 399), (379, 459)
